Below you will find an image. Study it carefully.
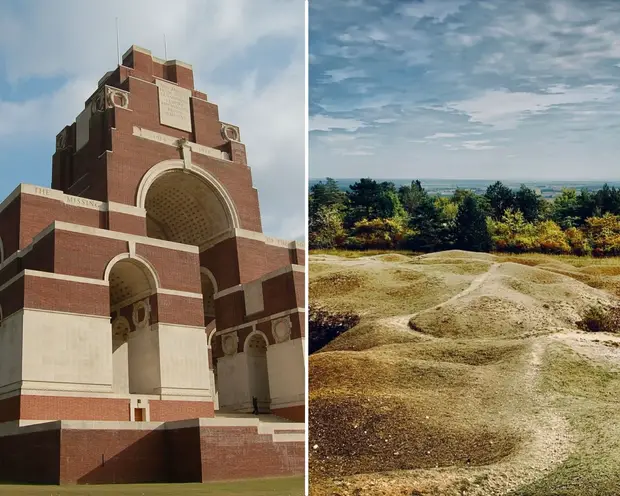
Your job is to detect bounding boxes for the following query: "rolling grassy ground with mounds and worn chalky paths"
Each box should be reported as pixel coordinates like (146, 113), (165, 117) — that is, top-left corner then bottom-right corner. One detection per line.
(309, 250), (620, 496)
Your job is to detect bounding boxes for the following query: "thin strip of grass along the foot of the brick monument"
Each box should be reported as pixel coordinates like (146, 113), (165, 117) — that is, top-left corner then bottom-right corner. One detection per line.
(0, 477), (304, 496)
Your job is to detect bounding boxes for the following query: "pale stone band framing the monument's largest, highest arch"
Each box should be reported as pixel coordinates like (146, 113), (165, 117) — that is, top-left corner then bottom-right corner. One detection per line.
(136, 159), (240, 243)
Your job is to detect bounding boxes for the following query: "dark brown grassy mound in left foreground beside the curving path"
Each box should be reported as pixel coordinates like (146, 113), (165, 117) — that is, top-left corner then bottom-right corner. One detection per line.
(309, 396), (518, 476)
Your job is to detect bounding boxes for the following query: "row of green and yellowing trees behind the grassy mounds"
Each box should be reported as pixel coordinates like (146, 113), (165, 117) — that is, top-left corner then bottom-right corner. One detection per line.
(309, 178), (620, 256)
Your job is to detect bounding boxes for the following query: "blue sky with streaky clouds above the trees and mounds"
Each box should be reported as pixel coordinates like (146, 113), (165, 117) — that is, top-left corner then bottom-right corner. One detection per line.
(309, 0), (620, 180)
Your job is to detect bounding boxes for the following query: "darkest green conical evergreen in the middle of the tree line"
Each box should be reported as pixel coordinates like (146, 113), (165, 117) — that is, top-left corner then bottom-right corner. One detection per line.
(455, 195), (491, 251)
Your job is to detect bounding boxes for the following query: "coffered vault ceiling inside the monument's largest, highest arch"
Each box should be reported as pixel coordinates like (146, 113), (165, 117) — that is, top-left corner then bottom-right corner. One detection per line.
(145, 170), (233, 246)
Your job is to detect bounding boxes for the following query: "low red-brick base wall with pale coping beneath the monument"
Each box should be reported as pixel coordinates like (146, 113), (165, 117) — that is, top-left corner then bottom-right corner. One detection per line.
(0, 417), (305, 484)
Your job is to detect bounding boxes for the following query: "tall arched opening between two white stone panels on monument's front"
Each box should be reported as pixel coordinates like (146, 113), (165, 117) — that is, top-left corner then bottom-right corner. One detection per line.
(106, 255), (160, 394)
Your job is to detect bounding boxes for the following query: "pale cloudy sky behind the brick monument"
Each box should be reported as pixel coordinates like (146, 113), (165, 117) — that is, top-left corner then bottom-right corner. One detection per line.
(0, 0), (305, 239)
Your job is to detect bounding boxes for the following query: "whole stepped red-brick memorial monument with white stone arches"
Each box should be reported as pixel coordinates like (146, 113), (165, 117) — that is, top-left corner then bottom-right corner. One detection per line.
(0, 46), (306, 484)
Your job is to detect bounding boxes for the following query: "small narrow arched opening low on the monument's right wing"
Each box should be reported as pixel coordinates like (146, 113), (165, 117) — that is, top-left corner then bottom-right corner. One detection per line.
(244, 331), (271, 413)
